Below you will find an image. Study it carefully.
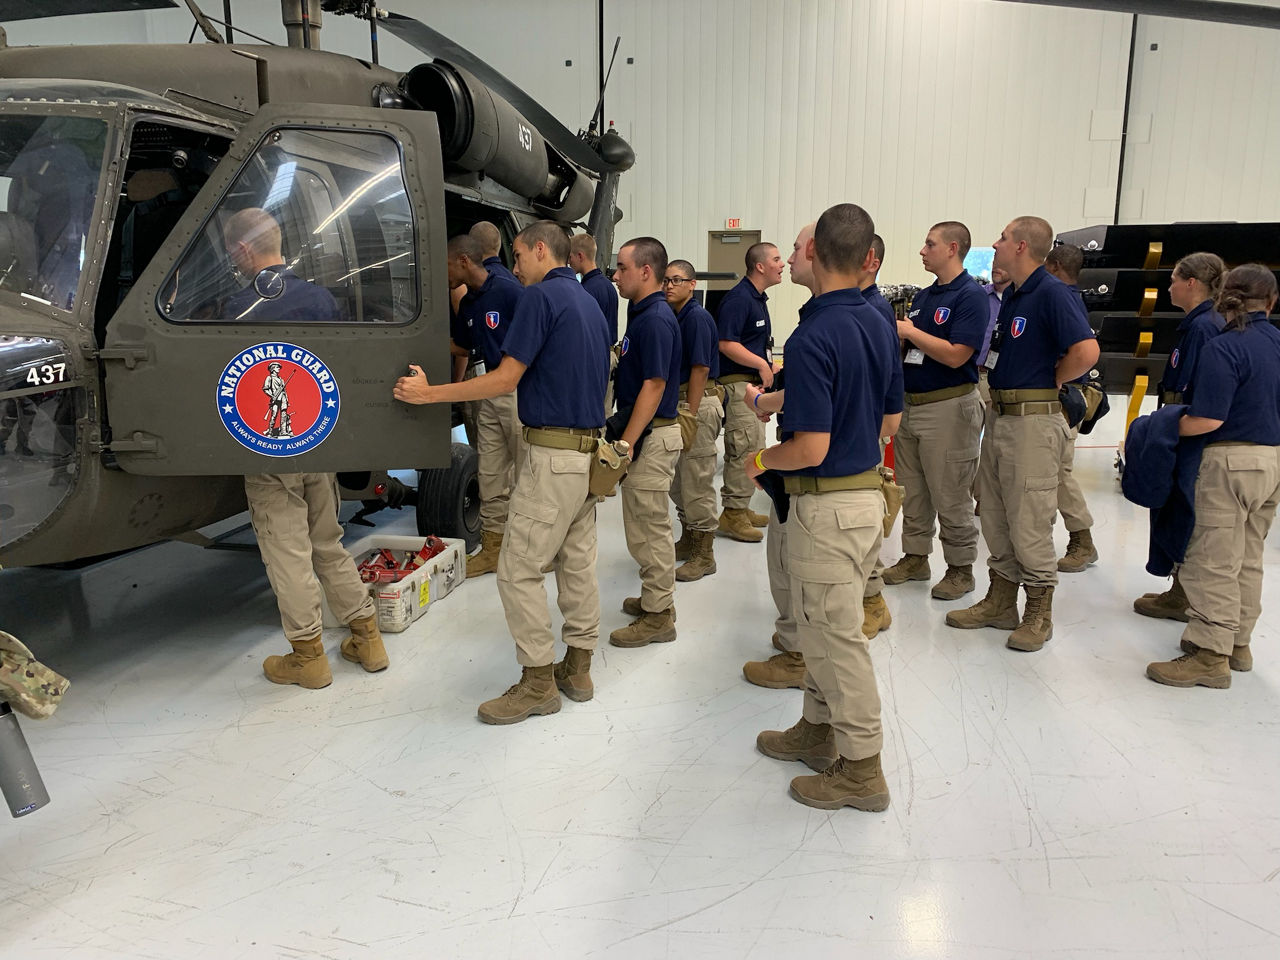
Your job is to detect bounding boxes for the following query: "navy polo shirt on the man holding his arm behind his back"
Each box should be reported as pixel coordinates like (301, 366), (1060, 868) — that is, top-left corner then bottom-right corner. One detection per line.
(979, 266), (1093, 390)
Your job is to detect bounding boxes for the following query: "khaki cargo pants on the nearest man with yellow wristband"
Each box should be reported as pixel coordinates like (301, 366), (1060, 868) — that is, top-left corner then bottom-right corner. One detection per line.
(787, 490), (884, 760)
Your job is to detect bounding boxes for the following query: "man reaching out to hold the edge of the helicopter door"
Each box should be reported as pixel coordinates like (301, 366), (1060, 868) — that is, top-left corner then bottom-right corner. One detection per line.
(394, 220), (609, 723)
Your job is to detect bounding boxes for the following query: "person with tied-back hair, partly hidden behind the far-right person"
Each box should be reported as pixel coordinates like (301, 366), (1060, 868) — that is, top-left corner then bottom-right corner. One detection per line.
(1133, 252), (1226, 623)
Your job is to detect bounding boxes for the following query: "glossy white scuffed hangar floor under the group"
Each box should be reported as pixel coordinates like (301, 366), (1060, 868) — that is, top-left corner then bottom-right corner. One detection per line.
(0, 411), (1280, 960)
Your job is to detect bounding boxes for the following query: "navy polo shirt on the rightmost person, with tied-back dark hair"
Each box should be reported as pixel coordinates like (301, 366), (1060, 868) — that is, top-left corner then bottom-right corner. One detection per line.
(1187, 317), (1280, 447)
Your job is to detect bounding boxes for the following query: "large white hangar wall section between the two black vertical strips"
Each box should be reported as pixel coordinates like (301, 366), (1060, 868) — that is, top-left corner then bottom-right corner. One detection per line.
(605, 0), (1129, 339)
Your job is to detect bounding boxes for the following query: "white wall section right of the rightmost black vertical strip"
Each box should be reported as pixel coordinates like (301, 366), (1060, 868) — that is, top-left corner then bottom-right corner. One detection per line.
(1121, 17), (1280, 223)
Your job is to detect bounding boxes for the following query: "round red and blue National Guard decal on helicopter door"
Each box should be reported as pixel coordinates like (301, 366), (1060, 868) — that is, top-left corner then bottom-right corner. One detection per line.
(216, 343), (342, 457)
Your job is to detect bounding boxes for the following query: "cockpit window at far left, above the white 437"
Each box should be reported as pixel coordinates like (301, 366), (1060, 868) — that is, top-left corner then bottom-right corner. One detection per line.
(0, 114), (106, 310)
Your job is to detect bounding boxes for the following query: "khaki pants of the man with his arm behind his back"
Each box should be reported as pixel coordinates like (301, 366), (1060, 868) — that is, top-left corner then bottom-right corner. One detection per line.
(978, 410), (1068, 586)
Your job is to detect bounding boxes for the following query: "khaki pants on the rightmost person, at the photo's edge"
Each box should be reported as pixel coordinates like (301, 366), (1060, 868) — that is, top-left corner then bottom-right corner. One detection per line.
(1178, 444), (1280, 654)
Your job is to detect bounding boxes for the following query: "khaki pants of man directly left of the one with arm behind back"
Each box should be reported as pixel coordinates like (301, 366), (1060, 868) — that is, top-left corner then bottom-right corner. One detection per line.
(893, 390), (983, 567)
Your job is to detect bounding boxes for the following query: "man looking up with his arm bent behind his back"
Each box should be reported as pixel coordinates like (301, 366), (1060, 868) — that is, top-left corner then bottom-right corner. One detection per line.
(947, 216), (1098, 650)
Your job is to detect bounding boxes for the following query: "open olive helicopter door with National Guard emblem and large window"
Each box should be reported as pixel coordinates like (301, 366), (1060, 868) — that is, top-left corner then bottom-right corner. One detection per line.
(101, 104), (449, 475)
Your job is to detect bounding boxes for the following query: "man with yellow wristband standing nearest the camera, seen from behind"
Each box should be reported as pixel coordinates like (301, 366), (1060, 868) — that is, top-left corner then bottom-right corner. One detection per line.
(746, 204), (902, 810)
